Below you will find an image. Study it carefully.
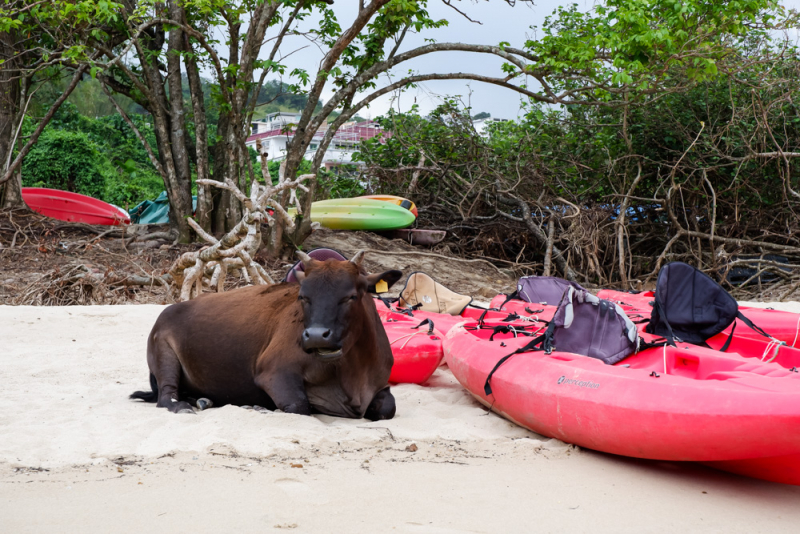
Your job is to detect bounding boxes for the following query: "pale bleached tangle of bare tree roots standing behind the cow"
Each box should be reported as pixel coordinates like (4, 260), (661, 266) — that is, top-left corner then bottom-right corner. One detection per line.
(170, 170), (314, 300)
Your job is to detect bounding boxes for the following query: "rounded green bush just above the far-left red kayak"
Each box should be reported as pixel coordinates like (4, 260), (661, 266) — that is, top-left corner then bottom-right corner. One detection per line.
(22, 130), (111, 198)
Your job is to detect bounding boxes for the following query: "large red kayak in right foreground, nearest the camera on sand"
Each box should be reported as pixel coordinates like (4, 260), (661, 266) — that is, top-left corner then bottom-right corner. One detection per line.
(444, 323), (800, 485)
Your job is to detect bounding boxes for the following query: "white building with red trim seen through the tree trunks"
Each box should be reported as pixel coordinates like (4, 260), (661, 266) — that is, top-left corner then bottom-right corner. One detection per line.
(245, 112), (385, 169)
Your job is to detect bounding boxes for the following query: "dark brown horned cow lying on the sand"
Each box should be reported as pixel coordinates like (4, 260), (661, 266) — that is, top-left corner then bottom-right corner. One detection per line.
(130, 251), (402, 420)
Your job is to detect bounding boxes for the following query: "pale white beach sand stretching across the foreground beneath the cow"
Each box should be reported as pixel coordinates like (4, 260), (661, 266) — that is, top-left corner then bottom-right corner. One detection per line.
(0, 303), (800, 533)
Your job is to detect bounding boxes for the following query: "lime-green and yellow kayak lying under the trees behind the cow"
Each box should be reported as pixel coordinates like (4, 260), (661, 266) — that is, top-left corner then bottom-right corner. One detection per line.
(289, 198), (416, 230)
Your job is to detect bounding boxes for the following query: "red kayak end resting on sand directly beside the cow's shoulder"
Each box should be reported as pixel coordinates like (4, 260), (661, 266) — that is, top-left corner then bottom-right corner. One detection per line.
(381, 312), (444, 384)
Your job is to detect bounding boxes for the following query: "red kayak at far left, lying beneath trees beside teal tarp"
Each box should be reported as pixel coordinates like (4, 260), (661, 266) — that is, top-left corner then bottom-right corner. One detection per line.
(22, 187), (131, 226)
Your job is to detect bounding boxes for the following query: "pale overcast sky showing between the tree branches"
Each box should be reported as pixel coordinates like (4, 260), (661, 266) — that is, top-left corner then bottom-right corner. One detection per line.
(265, 0), (800, 119)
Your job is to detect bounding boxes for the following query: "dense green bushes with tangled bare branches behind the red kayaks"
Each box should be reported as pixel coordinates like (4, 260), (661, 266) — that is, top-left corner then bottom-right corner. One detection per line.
(357, 45), (800, 284)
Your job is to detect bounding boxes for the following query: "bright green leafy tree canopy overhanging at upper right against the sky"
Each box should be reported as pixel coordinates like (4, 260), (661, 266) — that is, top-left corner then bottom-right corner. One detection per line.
(520, 0), (784, 100)
